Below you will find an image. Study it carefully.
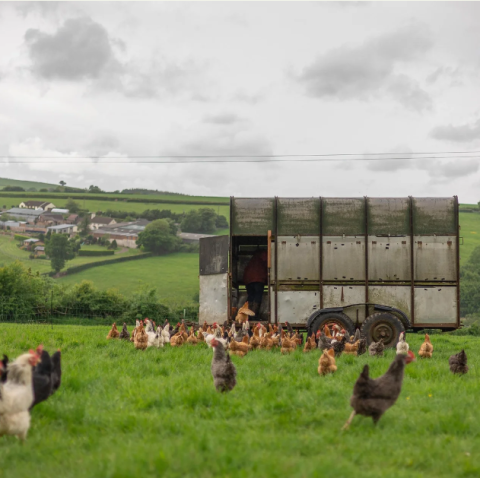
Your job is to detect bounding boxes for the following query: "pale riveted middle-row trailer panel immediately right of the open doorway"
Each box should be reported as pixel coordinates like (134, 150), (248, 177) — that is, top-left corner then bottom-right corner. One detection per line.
(274, 236), (320, 281)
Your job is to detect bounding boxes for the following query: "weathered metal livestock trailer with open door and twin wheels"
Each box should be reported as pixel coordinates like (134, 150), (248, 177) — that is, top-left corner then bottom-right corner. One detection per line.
(199, 196), (460, 346)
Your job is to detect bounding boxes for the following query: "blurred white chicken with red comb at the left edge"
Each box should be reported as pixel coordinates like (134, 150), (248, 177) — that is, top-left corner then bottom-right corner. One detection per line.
(0, 346), (42, 441)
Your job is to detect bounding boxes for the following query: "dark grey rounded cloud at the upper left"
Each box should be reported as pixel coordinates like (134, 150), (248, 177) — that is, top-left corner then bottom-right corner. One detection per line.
(25, 17), (117, 81)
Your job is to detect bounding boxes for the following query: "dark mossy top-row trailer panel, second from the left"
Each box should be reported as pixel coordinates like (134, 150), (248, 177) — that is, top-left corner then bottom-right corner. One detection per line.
(277, 198), (320, 236)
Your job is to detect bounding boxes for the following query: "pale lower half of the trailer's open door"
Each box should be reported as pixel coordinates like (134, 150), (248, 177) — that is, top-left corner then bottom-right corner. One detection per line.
(198, 274), (228, 324)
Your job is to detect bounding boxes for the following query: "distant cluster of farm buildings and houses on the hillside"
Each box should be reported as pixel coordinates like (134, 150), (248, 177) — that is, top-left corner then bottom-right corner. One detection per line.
(0, 201), (214, 253)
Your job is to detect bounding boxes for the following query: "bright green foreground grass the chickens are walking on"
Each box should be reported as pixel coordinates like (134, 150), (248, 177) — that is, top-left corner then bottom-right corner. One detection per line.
(0, 325), (480, 478)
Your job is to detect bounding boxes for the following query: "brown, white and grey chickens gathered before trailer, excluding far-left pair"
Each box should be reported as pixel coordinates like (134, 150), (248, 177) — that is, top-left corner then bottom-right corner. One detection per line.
(107, 306), (468, 429)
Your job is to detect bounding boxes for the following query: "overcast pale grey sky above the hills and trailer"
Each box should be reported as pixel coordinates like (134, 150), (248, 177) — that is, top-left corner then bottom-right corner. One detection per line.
(0, 2), (480, 203)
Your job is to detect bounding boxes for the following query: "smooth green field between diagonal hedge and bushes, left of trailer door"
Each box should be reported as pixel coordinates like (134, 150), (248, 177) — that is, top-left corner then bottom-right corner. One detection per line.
(58, 253), (199, 304)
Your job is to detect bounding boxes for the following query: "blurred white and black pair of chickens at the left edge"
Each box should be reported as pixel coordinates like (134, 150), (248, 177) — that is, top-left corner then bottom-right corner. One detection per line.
(0, 345), (62, 441)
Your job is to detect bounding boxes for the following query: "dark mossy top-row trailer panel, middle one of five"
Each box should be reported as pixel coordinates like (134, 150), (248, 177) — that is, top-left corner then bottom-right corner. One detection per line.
(322, 198), (366, 236)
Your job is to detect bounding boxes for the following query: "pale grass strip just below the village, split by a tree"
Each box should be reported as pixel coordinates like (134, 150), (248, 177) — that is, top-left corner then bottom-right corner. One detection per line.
(0, 235), (141, 273)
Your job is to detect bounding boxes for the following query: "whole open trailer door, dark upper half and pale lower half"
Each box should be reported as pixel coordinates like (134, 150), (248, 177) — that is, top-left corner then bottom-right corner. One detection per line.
(198, 236), (230, 324)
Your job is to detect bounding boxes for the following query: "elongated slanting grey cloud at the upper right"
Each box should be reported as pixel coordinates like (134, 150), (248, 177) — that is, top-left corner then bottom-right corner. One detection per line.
(297, 25), (431, 108)
